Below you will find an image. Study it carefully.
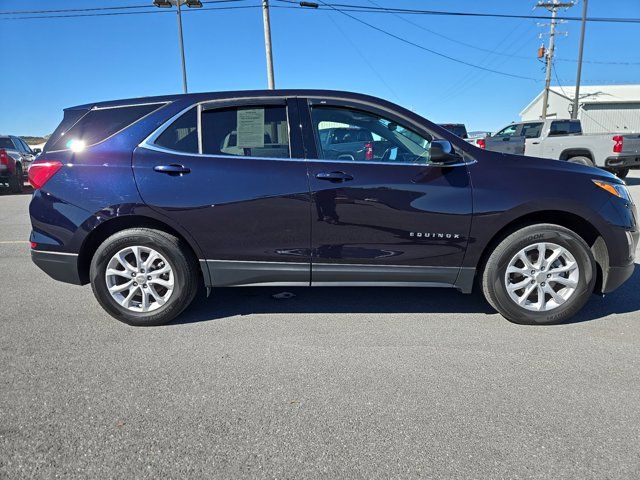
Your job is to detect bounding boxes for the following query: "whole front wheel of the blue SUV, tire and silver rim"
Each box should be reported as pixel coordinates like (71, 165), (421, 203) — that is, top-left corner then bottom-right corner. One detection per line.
(481, 224), (597, 325)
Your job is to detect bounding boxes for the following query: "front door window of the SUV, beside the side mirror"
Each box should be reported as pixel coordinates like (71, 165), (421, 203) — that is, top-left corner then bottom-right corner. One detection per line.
(311, 107), (431, 163)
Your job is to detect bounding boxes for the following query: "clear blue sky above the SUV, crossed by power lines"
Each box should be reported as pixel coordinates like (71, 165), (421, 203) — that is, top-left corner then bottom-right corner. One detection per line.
(0, 0), (640, 135)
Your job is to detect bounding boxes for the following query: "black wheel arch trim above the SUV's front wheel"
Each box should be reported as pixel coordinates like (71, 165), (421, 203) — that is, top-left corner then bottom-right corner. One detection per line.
(477, 210), (609, 292)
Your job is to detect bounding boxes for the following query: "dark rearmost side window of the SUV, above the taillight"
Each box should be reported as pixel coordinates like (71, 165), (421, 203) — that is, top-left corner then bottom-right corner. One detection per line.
(51, 104), (161, 150)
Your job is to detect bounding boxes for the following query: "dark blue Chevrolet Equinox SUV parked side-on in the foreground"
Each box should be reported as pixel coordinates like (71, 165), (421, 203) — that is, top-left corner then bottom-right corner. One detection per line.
(29, 90), (638, 325)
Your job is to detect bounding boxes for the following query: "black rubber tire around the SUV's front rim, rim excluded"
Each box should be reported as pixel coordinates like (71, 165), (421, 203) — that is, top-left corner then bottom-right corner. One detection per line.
(487, 227), (596, 324)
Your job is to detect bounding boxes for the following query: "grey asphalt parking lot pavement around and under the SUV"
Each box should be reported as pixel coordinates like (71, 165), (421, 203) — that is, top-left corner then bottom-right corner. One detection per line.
(0, 176), (640, 479)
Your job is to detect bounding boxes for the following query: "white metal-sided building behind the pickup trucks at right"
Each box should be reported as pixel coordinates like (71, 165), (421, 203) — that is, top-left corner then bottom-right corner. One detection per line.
(520, 85), (640, 133)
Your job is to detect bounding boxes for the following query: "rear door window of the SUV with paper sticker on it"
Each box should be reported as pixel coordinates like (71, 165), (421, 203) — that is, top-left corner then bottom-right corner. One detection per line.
(201, 106), (289, 158)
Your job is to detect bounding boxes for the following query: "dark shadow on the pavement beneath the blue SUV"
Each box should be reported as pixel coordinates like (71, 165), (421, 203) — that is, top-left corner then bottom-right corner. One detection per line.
(171, 264), (640, 325)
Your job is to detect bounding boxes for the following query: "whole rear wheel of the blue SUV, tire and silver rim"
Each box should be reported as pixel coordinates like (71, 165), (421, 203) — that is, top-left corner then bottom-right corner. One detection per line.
(89, 228), (199, 326)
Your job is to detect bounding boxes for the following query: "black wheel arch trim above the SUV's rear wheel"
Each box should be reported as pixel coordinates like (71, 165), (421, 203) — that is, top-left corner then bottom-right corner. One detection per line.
(78, 214), (209, 285)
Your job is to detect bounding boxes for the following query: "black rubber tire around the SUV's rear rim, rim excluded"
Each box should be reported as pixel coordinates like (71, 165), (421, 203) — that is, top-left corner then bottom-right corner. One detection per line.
(90, 229), (197, 326)
